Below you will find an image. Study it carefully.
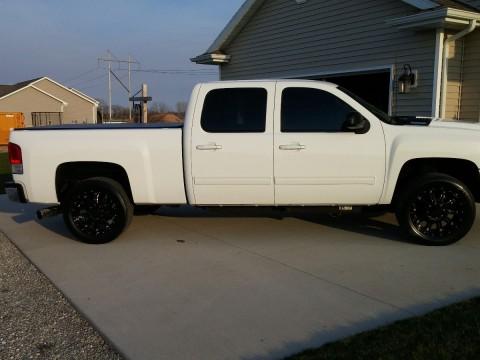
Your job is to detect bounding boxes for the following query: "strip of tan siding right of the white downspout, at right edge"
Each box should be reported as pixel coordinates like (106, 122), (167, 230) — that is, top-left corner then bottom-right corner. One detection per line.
(460, 30), (480, 122)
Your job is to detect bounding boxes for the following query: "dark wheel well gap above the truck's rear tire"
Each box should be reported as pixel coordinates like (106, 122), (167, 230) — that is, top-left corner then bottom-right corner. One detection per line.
(55, 162), (133, 202)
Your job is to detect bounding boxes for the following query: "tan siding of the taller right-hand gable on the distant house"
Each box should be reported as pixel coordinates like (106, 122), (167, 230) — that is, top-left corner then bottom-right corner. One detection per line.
(35, 79), (97, 124)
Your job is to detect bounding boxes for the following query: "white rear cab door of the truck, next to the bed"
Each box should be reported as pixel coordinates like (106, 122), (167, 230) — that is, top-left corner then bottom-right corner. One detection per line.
(191, 82), (275, 205)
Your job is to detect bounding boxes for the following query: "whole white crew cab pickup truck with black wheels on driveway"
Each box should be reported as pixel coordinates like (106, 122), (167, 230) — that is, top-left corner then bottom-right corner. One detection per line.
(6, 80), (480, 245)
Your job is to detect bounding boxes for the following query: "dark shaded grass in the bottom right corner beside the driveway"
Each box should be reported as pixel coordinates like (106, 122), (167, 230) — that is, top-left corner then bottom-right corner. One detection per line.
(288, 298), (480, 360)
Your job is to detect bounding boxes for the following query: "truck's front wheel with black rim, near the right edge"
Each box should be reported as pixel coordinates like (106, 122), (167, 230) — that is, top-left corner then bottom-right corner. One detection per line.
(396, 173), (476, 246)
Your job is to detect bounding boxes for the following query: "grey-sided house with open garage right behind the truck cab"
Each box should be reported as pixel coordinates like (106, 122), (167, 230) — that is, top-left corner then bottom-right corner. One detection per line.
(192, 0), (480, 122)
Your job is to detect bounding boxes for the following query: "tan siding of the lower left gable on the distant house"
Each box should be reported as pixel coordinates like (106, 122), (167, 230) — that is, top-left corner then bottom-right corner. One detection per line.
(0, 87), (62, 126)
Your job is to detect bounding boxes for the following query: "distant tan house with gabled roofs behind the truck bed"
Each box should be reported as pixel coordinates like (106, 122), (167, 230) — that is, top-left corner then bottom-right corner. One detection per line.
(0, 77), (99, 126)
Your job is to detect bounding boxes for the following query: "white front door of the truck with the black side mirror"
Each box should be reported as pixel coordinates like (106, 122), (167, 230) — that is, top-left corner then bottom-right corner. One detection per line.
(274, 82), (385, 205)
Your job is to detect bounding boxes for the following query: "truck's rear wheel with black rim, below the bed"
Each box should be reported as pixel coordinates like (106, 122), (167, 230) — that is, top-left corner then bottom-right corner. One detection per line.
(62, 177), (133, 244)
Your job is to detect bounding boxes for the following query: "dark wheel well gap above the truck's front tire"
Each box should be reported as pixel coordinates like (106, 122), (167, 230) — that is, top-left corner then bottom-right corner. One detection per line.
(392, 158), (480, 203)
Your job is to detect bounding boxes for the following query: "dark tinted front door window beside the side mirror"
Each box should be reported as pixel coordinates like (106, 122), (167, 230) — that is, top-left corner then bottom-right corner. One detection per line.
(282, 88), (355, 132)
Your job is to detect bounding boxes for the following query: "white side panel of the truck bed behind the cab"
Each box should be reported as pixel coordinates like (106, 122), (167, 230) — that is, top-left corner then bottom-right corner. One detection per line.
(10, 124), (186, 204)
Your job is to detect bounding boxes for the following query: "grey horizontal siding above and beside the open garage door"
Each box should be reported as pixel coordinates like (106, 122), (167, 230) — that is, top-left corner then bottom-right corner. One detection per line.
(221, 0), (436, 116)
